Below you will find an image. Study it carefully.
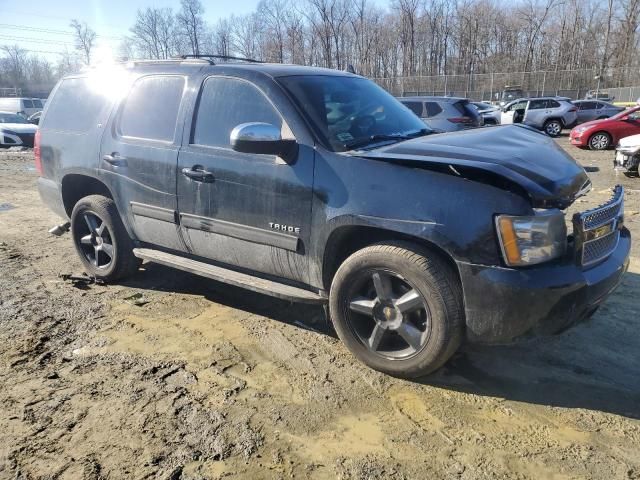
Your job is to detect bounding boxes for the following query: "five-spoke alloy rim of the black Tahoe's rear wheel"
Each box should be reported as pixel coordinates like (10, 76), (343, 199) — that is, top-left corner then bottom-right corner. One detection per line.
(77, 212), (115, 269)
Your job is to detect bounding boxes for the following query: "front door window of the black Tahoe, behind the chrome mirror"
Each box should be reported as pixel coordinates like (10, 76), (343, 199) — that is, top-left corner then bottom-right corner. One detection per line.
(191, 77), (283, 148)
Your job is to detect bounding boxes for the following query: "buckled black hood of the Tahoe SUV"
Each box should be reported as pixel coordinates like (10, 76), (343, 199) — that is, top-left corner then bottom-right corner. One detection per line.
(354, 125), (591, 208)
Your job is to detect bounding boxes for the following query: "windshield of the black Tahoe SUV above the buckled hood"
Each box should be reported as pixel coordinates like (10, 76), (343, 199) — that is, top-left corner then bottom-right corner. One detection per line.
(277, 75), (431, 152)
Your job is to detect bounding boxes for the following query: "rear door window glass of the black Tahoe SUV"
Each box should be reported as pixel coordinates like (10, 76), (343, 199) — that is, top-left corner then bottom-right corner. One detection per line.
(118, 75), (184, 142)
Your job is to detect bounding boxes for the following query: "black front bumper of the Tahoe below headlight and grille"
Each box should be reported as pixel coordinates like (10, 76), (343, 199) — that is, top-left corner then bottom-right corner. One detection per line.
(458, 229), (631, 343)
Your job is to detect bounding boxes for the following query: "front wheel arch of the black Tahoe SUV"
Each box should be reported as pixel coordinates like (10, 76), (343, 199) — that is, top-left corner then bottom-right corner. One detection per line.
(322, 225), (462, 291)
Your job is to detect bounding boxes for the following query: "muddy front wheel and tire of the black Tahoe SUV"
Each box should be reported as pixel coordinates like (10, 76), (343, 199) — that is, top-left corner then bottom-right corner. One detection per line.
(329, 242), (464, 378)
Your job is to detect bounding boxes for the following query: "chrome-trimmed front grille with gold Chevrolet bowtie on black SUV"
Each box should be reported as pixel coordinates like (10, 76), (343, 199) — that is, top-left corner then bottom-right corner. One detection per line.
(573, 185), (624, 266)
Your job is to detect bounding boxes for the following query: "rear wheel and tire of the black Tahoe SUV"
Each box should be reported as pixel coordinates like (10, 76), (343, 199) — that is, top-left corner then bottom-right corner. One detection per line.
(71, 195), (140, 282)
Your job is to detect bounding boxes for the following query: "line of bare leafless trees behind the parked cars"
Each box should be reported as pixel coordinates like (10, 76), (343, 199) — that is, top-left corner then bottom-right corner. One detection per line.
(0, 0), (640, 94)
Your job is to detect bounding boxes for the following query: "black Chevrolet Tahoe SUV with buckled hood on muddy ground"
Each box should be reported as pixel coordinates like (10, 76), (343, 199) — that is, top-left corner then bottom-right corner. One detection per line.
(36, 59), (630, 377)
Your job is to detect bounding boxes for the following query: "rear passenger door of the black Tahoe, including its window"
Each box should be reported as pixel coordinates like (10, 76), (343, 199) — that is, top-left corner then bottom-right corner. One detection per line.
(99, 74), (186, 251)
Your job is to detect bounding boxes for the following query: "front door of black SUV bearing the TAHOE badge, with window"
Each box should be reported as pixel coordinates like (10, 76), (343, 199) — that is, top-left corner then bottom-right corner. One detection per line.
(177, 76), (314, 283)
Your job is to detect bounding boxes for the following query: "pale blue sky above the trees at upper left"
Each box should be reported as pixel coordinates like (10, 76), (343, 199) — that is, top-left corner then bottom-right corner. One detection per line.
(0, 0), (258, 61)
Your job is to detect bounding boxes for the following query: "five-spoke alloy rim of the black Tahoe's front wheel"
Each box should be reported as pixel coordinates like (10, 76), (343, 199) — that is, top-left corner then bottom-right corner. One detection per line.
(347, 270), (431, 359)
